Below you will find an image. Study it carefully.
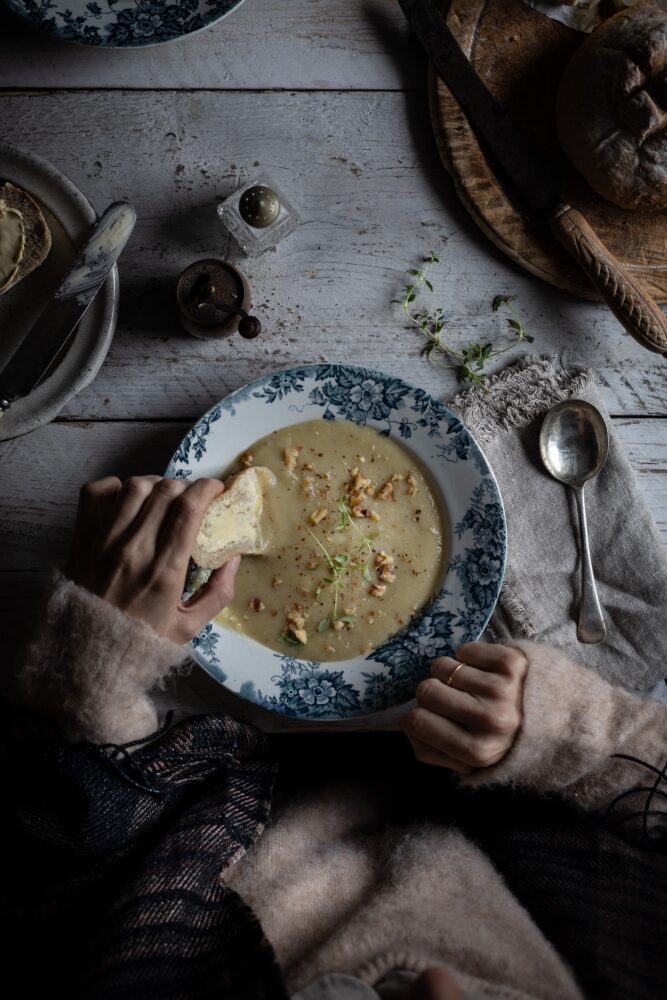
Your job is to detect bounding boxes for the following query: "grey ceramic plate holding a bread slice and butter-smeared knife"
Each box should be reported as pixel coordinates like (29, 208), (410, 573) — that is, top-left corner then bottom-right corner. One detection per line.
(0, 142), (118, 441)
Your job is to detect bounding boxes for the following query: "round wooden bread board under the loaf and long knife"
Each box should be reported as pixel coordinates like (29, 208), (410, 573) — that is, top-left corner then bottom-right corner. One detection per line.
(429, 0), (667, 302)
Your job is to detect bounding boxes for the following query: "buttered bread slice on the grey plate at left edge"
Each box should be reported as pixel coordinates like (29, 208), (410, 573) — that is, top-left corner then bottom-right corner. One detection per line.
(0, 182), (51, 295)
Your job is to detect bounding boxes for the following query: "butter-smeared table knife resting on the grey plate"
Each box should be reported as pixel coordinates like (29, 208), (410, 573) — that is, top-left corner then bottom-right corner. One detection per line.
(0, 201), (137, 417)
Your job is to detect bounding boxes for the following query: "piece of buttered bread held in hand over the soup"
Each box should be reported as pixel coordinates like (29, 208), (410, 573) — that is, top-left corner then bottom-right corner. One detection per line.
(192, 466), (276, 569)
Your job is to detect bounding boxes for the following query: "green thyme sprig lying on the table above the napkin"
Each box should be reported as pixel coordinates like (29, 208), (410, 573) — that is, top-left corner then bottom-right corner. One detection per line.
(392, 250), (535, 388)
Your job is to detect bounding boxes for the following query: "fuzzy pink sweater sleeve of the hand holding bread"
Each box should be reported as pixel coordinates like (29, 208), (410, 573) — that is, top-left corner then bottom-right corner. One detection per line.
(14, 575), (188, 743)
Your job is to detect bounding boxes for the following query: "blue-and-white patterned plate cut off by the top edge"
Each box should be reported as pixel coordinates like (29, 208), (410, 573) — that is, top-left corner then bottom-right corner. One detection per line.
(5, 0), (243, 48)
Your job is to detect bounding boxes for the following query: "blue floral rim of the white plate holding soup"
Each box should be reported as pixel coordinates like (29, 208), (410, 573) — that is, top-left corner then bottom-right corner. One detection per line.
(165, 365), (506, 719)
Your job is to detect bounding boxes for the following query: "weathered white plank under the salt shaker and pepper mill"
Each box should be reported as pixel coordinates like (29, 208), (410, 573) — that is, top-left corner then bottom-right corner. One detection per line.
(0, 91), (667, 419)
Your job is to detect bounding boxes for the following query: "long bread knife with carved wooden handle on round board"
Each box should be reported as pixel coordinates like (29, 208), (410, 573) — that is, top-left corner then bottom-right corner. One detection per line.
(399, 0), (667, 355)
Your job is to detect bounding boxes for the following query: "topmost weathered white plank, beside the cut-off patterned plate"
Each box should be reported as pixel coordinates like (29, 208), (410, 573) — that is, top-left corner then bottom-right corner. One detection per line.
(0, 0), (425, 90)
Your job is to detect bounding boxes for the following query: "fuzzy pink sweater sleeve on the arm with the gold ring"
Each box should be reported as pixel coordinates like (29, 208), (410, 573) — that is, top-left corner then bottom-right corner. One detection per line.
(466, 642), (667, 826)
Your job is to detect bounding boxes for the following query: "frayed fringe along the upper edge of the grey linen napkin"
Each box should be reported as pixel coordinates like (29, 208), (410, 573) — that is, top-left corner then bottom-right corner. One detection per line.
(450, 354), (593, 444)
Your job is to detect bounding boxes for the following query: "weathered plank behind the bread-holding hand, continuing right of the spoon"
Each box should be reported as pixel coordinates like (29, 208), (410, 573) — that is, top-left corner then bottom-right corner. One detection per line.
(0, 419), (667, 574)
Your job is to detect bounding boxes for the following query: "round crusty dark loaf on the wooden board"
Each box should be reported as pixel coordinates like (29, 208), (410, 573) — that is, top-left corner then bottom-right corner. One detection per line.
(556, 0), (667, 209)
